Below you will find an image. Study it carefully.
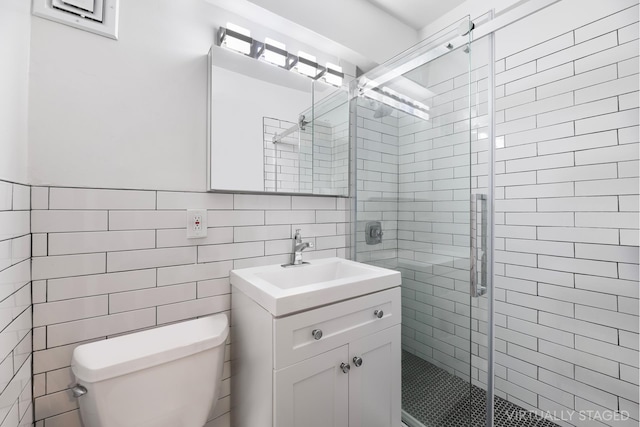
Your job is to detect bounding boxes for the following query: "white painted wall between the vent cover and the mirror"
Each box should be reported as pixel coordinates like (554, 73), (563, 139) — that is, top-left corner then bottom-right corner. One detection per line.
(29, 0), (222, 190)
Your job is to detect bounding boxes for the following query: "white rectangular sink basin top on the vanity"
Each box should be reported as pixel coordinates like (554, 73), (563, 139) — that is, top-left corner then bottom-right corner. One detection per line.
(231, 258), (400, 317)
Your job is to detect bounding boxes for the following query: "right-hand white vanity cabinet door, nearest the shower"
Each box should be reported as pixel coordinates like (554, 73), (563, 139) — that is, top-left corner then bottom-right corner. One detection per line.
(349, 325), (401, 427)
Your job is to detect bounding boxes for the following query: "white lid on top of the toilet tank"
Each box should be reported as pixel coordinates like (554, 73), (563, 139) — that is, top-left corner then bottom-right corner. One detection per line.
(71, 314), (229, 383)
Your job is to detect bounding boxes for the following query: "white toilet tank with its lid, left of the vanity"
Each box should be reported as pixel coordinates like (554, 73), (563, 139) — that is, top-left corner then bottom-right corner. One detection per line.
(71, 314), (229, 427)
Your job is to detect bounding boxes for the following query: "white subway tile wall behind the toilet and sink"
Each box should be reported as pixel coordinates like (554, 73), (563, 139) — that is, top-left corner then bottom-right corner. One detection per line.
(32, 188), (349, 427)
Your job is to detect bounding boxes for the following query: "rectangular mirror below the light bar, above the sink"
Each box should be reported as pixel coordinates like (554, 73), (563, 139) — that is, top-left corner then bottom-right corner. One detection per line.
(208, 46), (349, 196)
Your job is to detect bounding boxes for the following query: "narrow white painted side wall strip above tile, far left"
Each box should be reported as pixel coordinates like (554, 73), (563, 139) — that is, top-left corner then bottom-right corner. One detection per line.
(0, 0), (31, 183)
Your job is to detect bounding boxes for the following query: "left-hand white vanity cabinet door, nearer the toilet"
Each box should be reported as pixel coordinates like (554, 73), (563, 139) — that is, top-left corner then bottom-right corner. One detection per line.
(273, 345), (348, 427)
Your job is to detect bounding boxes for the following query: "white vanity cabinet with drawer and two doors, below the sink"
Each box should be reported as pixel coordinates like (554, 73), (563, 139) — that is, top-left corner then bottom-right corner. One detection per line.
(231, 287), (401, 427)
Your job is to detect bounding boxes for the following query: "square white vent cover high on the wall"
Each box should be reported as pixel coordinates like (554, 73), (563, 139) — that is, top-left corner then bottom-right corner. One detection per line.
(33, 0), (119, 40)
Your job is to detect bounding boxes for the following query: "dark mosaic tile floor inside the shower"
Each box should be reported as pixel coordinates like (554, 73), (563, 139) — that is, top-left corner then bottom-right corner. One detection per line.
(402, 351), (558, 427)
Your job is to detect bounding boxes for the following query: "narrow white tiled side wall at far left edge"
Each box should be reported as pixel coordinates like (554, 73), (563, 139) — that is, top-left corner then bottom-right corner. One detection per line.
(0, 181), (33, 427)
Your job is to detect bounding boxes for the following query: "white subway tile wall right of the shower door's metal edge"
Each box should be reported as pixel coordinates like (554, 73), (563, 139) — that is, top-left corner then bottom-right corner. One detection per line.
(496, 4), (640, 426)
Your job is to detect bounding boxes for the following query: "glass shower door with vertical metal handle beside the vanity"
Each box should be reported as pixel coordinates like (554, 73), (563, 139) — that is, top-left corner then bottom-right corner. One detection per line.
(353, 20), (488, 427)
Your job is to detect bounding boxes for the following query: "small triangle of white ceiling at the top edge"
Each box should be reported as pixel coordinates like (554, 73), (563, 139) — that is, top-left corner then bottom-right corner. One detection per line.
(367, 0), (465, 31)
